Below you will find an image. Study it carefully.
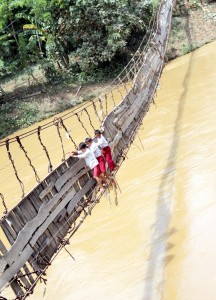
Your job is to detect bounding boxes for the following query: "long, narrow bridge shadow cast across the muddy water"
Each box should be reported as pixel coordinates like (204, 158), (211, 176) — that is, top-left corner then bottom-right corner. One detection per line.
(143, 16), (194, 300)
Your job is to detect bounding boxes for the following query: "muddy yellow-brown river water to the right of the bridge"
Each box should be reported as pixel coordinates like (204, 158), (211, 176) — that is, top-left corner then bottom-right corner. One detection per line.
(1, 43), (216, 300)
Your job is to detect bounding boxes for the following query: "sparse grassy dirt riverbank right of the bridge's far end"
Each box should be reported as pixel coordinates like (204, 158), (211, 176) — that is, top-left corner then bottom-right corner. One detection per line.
(167, 2), (216, 60)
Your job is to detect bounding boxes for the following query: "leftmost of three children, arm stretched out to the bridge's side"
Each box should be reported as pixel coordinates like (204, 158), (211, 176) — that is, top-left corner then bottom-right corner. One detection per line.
(72, 143), (104, 192)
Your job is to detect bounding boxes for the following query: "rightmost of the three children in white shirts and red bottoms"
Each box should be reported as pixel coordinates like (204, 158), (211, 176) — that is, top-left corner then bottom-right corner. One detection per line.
(95, 130), (116, 171)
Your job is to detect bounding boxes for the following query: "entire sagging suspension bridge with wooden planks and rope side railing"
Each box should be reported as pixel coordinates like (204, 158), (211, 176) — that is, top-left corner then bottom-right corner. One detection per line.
(0, 0), (174, 299)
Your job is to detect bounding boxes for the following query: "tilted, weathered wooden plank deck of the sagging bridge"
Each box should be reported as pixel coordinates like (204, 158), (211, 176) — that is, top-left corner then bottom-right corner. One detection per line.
(0, 0), (173, 299)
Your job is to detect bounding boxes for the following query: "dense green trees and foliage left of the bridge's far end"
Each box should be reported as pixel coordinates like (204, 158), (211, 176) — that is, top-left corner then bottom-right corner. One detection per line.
(0, 0), (154, 79)
